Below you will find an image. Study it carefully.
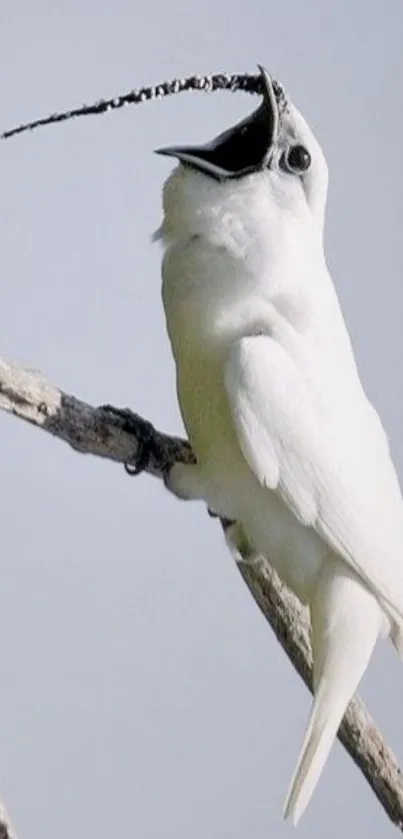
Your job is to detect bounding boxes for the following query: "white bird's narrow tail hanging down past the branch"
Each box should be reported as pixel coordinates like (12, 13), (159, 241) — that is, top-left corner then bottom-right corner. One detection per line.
(284, 560), (384, 824)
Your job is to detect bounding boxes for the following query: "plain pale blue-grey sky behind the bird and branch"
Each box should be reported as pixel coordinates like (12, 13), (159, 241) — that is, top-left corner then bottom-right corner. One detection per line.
(0, 0), (403, 839)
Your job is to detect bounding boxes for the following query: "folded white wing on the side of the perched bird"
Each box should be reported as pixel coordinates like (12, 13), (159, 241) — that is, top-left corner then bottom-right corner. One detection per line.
(225, 335), (403, 634)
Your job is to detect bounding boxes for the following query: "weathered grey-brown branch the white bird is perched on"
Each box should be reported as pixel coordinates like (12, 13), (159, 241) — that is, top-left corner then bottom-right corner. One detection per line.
(0, 361), (403, 839)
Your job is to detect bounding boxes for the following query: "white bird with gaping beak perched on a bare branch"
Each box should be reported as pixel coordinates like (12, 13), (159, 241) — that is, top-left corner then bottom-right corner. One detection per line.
(149, 68), (403, 823)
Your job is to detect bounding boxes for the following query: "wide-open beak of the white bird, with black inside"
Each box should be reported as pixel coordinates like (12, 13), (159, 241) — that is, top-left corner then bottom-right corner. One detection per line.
(156, 65), (279, 181)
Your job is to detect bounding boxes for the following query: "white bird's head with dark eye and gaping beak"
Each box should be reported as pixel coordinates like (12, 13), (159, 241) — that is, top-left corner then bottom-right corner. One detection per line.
(157, 67), (328, 244)
